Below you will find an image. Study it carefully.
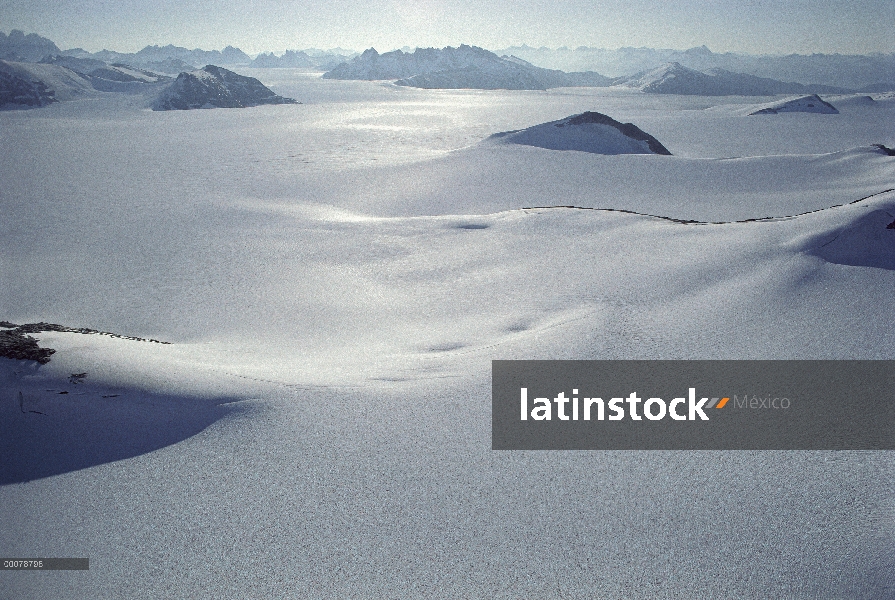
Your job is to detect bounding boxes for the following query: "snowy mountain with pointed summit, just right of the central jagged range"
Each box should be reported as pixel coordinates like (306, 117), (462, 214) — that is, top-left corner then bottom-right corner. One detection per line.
(618, 62), (849, 96)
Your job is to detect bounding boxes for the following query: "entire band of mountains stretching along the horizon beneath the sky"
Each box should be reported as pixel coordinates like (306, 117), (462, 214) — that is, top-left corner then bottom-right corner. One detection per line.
(0, 30), (895, 108)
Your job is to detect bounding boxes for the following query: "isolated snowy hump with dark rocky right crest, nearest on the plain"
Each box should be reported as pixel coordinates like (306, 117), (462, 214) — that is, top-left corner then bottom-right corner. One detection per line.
(489, 112), (671, 155)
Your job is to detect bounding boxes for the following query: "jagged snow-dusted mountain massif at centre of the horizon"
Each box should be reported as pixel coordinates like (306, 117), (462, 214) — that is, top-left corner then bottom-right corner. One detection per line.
(323, 45), (611, 90)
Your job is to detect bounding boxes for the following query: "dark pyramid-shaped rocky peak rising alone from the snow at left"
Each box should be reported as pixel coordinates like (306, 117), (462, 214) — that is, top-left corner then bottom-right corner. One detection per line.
(152, 65), (296, 110)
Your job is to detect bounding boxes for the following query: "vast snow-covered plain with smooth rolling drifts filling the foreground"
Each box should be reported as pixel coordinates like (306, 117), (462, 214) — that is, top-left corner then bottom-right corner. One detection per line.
(0, 69), (895, 598)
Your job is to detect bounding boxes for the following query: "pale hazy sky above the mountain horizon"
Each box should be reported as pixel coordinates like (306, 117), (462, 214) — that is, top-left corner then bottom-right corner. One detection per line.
(0, 0), (895, 54)
